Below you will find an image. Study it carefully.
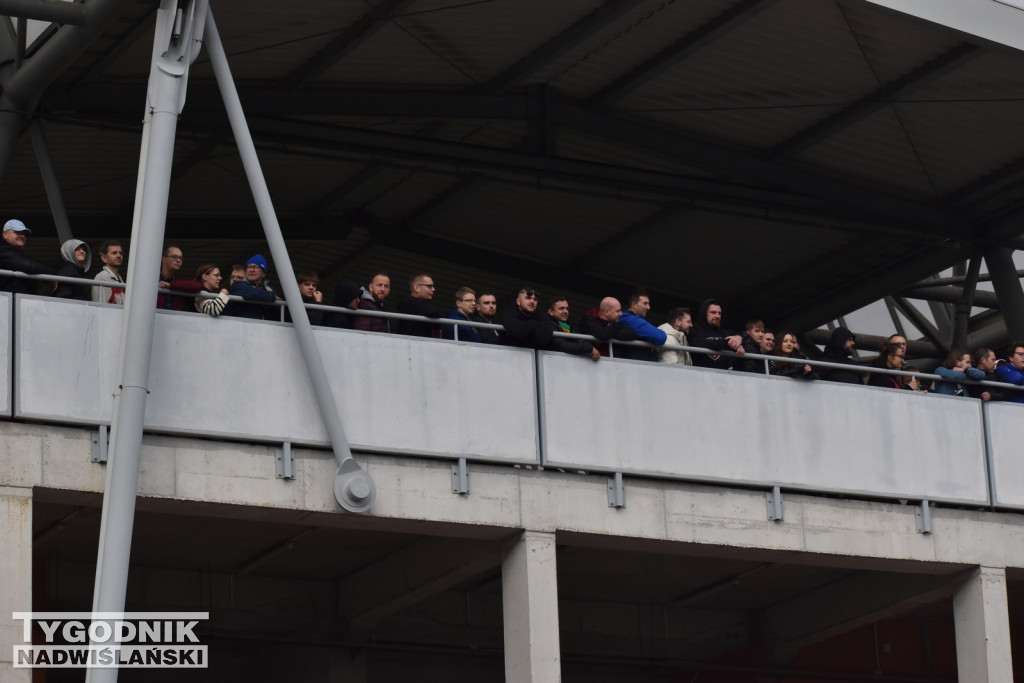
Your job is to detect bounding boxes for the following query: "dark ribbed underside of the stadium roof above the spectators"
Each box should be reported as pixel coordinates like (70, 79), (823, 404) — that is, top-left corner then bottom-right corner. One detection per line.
(0, 0), (1024, 329)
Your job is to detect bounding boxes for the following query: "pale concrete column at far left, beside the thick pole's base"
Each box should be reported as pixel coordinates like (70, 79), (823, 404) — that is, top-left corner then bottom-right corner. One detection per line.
(0, 486), (33, 683)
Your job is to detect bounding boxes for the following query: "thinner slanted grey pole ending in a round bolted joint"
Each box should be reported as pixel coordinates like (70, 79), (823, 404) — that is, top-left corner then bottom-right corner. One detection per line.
(206, 10), (377, 512)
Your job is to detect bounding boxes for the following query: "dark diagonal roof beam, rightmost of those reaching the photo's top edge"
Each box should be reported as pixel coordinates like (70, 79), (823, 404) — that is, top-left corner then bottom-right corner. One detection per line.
(585, 0), (776, 108)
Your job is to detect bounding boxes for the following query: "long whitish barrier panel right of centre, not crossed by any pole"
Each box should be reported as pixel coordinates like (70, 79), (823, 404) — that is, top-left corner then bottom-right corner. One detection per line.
(541, 353), (988, 504)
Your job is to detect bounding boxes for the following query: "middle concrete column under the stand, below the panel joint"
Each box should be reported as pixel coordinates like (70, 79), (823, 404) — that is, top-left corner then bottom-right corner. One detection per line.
(502, 531), (561, 683)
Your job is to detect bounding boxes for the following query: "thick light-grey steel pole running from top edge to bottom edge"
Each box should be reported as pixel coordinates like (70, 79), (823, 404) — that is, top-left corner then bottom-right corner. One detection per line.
(86, 0), (207, 683)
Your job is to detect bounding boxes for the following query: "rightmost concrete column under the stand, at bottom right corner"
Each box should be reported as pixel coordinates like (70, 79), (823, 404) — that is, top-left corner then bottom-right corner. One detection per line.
(953, 567), (1014, 683)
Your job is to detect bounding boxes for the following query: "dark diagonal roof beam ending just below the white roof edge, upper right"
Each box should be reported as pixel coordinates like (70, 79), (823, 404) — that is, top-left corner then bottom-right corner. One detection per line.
(766, 43), (985, 161)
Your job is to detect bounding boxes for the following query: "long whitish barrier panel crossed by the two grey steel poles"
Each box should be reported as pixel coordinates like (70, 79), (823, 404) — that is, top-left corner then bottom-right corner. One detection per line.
(14, 297), (540, 463)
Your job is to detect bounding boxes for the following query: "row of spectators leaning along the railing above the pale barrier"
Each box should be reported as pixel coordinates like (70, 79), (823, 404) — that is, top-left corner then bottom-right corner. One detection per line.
(0, 219), (1024, 402)
